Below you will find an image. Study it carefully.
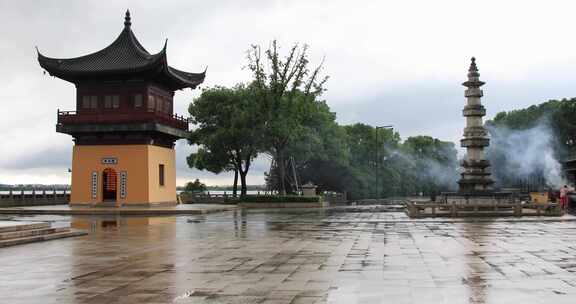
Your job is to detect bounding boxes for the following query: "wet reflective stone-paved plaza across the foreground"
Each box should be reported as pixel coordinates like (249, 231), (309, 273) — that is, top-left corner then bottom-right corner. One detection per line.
(0, 209), (576, 304)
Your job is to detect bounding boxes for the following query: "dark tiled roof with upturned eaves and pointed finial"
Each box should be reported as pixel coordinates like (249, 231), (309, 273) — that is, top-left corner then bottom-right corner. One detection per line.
(38, 12), (205, 89)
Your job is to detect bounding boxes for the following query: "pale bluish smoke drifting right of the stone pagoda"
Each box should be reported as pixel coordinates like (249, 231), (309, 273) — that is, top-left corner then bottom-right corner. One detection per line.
(487, 120), (566, 189)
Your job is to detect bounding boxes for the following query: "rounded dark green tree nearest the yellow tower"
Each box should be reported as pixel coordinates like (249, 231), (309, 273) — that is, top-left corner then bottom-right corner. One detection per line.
(188, 85), (263, 195)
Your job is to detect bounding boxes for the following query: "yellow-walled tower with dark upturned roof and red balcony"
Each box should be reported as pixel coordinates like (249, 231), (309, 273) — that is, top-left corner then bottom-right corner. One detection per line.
(38, 12), (205, 206)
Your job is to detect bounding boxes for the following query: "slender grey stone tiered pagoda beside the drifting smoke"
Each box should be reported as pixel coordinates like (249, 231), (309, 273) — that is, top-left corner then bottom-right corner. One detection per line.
(458, 57), (494, 193)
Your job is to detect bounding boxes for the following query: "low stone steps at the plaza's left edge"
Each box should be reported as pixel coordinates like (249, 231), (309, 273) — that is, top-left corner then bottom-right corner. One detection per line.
(0, 222), (87, 248)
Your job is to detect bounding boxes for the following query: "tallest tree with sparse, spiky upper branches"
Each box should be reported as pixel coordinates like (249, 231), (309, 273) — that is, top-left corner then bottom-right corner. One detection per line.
(248, 40), (328, 194)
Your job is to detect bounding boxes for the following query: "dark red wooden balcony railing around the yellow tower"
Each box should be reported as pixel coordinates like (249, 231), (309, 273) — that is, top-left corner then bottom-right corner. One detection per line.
(58, 110), (188, 131)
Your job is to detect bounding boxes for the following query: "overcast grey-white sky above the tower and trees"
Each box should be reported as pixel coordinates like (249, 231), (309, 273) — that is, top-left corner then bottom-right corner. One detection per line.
(0, 0), (576, 184)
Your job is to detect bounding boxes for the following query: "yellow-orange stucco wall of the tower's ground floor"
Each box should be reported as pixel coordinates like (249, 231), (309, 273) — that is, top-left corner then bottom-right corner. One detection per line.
(70, 145), (176, 204)
